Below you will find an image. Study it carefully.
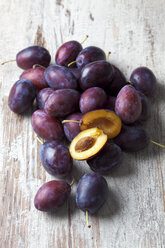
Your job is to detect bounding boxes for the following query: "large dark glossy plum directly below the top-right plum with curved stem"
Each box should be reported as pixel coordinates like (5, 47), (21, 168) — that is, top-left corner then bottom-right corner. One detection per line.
(79, 60), (113, 90)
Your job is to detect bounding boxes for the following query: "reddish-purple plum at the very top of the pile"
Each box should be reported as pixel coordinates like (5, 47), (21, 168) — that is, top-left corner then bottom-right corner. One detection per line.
(55, 40), (82, 67)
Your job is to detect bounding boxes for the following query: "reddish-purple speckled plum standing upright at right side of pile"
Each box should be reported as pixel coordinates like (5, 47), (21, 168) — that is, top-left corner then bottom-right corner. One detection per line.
(115, 85), (142, 124)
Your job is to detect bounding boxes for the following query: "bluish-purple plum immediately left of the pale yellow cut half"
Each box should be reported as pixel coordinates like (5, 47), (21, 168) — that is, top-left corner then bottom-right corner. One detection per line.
(40, 141), (73, 177)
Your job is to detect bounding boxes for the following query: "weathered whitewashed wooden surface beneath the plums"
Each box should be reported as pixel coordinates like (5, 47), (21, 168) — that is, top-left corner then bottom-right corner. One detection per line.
(0, 0), (165, 248)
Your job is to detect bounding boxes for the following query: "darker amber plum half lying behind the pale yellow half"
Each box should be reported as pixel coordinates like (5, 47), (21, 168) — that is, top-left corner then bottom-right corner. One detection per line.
(80, 109), (121, 139)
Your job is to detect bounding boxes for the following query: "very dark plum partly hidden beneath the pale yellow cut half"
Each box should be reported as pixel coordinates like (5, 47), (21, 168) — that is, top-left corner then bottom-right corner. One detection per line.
(87, 143), (123, 174)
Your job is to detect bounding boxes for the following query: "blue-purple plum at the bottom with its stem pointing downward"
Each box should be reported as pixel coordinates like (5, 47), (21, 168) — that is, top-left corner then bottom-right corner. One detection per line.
(76, 172), (108, 214)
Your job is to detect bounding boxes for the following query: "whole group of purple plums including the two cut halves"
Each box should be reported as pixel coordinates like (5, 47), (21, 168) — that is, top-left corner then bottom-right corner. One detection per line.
(8, 36), (156, 227)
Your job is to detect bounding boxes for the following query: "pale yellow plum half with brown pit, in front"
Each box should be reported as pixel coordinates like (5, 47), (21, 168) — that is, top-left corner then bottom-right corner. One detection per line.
(69, 128), (108, 160)
